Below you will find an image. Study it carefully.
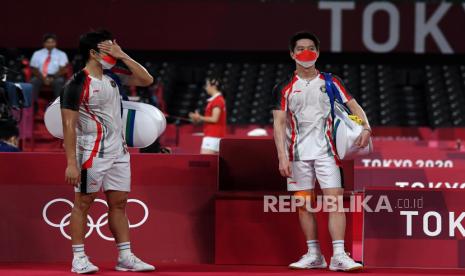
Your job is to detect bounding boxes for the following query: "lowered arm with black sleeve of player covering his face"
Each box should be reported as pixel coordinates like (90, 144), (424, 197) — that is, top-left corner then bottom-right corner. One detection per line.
(60, 76), (84, 186)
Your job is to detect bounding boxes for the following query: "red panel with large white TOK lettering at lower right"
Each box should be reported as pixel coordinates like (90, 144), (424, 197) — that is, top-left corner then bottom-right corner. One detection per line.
(363, 189), (465, 268)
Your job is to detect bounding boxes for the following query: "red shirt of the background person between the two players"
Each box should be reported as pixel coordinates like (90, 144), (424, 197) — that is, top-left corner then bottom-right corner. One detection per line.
(203, 93), (226, 138)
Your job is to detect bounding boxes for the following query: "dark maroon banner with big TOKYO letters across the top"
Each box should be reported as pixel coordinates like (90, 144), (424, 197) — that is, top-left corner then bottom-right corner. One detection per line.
(0, 0), (465, 54)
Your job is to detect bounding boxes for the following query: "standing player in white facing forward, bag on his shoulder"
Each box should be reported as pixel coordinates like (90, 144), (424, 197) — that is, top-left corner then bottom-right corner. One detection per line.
(272, 32), (371, 271)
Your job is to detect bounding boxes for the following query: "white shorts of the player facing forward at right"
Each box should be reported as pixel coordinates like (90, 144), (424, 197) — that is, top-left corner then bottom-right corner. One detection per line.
(287, 156), (344, 191)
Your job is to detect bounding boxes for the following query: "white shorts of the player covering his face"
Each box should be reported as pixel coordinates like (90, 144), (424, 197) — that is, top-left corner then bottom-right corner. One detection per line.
(74, 153), (131, 194)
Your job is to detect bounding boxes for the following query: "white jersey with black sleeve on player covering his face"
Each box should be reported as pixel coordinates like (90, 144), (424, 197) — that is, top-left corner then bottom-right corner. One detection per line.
(60, 70), (126, 169)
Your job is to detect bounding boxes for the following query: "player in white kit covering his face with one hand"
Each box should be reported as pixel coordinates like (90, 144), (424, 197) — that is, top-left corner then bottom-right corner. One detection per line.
(60, 31), (155, 274)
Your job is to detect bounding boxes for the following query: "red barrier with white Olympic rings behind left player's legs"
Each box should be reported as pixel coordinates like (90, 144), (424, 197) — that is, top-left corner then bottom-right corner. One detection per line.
(0, 153), (218, 263)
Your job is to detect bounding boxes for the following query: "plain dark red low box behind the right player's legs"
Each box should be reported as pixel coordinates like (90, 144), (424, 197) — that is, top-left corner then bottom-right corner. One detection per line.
(215, 192), (356, 265)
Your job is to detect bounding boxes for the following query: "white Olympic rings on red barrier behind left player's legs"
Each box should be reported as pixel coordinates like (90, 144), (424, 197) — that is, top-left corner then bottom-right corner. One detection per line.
(42, 198), (149, 241)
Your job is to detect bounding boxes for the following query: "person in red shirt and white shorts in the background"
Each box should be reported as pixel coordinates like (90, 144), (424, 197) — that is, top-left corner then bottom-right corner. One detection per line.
(189, 78), (226, 154)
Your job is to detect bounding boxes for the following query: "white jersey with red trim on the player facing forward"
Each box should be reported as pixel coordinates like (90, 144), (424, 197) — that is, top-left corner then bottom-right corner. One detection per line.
(273, 74), (352, 161)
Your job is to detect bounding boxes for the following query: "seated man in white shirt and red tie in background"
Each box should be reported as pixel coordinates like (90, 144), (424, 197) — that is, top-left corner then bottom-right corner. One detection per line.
(31, 33), (68, 103)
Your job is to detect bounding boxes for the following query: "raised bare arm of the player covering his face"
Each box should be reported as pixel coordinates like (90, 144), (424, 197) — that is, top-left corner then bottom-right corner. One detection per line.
(98, 40), (153, 86)
